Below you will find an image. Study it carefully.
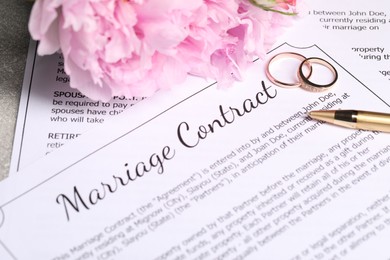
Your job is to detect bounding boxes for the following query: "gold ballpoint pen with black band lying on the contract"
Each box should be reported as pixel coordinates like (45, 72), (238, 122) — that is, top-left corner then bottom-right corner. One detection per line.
(309, 110), (390, 133)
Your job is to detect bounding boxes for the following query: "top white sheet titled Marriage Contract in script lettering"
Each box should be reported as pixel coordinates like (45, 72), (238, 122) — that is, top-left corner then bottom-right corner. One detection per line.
(0, 44), (390, 260)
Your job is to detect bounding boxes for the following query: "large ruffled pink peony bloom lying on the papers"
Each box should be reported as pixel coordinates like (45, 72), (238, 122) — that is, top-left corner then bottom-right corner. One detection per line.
(29, 0), (296, 101)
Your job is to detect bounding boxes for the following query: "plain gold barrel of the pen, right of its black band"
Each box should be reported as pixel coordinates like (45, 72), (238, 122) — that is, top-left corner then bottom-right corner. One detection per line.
(356, 111), (390, 133)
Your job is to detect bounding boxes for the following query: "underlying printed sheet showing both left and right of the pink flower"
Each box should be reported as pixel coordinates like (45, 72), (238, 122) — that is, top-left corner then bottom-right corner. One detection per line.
(10, 0), (390, 174)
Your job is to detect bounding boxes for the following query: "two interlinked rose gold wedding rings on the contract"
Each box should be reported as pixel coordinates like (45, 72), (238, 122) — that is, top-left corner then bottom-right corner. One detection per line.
(266, 52), (338, 92)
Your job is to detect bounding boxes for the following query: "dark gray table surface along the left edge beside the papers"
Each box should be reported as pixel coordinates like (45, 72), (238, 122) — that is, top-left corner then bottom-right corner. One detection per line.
(0, 0), (32, 180)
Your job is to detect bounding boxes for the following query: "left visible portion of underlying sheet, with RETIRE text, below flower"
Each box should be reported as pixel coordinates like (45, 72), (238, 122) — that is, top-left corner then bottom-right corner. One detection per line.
(10, 41), (147, 174)
